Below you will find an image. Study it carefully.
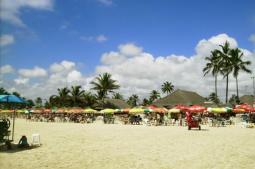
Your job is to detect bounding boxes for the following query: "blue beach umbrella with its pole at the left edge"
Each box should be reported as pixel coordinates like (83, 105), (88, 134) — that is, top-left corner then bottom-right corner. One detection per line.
(0, 95), (26, 140)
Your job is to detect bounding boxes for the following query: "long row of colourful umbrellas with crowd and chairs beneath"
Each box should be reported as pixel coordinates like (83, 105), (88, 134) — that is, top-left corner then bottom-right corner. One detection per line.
(1, 104), (255, 126)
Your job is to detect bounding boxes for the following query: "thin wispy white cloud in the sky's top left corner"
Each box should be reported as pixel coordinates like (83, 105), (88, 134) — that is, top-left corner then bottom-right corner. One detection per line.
(0, 0), (53, 27)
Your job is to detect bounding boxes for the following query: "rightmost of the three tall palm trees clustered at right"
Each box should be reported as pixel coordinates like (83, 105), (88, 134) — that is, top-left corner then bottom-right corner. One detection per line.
(230, 48), (251, 99)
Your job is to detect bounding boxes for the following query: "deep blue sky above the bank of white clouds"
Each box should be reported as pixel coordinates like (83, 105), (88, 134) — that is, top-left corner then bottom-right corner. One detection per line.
(0, 0), (255, 99)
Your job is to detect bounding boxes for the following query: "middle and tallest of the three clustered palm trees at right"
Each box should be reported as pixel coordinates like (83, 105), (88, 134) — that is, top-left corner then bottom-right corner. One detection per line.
(217, 41), (233, 104)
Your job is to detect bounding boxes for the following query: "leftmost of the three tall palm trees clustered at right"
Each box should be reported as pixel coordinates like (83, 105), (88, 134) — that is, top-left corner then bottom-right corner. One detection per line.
(203, 50), (221, 97)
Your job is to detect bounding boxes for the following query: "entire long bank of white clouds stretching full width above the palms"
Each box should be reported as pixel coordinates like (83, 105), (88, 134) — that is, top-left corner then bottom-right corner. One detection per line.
(1, 34), (255, 100)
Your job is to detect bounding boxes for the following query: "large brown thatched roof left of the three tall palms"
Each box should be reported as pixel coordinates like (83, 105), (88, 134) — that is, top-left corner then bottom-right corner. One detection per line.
(153, 89), (205, 107)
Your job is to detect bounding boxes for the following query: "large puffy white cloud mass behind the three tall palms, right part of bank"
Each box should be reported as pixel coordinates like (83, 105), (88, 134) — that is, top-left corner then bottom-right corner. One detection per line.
(96, 34), (255, 99)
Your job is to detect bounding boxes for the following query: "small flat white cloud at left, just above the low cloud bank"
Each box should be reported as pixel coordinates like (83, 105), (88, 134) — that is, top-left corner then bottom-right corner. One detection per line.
(18, 66), (47, 78)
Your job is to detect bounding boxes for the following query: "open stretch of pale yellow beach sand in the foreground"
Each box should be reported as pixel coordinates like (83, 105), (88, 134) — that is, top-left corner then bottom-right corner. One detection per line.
(0, 120), (255, 169)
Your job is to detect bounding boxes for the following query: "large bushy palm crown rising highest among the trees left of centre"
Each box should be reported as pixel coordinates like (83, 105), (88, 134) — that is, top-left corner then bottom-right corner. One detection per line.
(91, 73), (120, 100)
